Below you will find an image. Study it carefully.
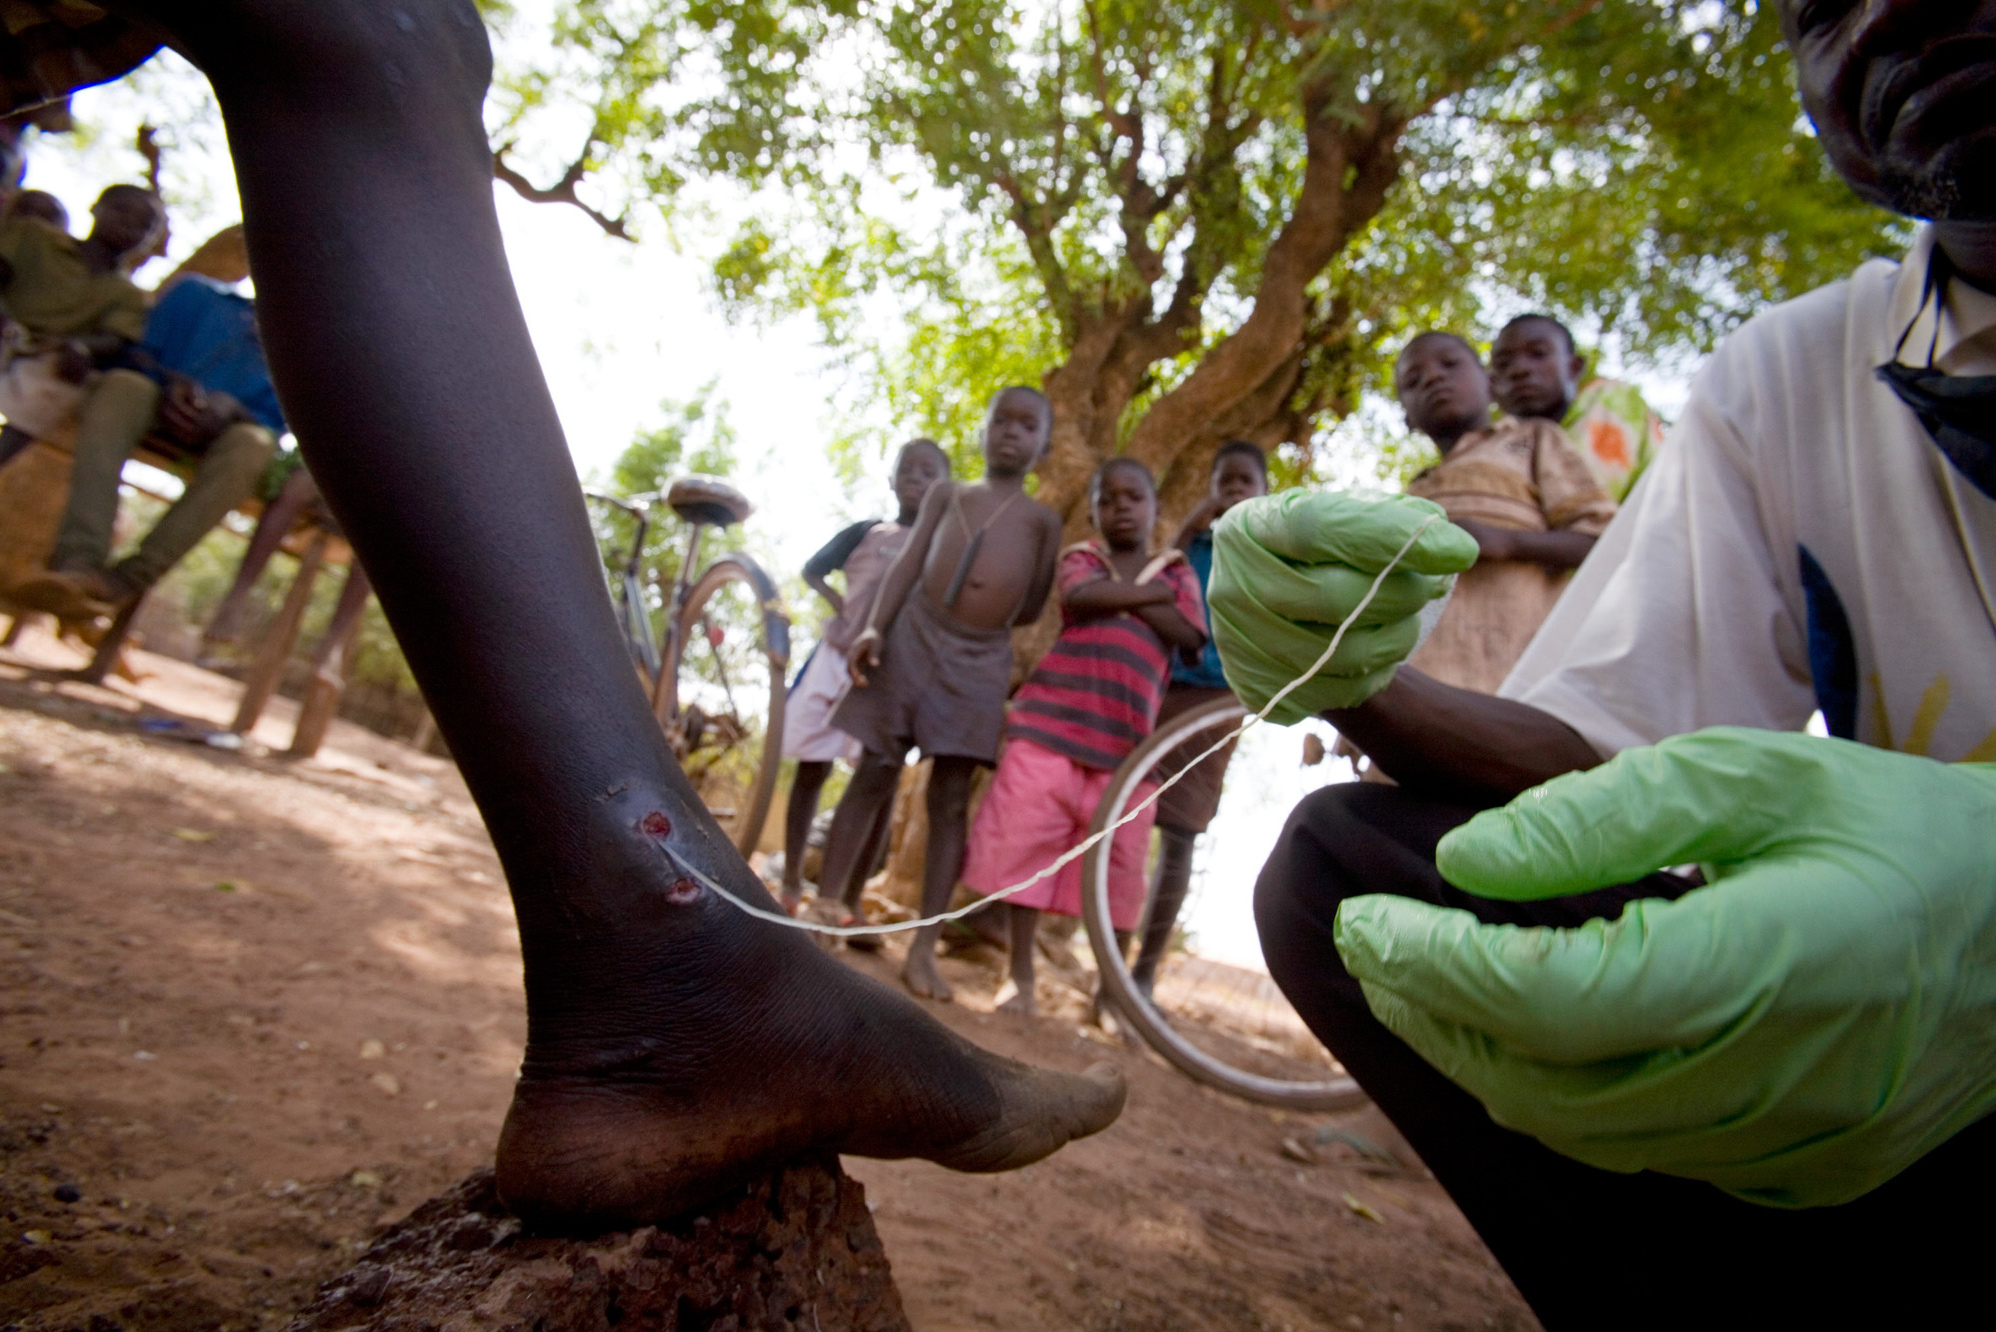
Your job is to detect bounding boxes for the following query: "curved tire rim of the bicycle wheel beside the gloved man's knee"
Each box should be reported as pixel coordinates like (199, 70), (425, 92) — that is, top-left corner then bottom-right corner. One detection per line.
(1082, 699), (1367, 1110)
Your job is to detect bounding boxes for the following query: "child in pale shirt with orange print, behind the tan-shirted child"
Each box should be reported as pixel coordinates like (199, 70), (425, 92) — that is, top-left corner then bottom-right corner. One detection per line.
(1491, 314), (1663, 503)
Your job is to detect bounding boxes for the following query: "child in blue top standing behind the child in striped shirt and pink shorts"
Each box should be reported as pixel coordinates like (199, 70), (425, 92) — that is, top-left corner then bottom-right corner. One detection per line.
(1130, 439), (1267, 995)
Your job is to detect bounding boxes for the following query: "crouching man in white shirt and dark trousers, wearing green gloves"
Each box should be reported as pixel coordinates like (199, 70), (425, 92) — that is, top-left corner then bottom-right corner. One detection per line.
(1245, 0), (1996, 1328)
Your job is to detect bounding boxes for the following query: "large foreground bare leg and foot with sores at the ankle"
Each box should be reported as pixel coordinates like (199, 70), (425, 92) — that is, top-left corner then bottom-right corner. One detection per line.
(118, 0), (1124, 1230)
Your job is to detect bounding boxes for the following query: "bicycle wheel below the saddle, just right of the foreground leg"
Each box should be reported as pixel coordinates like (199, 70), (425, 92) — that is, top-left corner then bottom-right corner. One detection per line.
(653, 553), (790, 855)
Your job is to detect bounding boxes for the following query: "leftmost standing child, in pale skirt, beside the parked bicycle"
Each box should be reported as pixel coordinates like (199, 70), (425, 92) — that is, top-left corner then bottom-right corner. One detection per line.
(782, 439), (950, 911)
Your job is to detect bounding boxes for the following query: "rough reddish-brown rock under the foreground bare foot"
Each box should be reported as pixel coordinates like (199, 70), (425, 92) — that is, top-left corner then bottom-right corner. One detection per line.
(289, 1158), (908, 1332)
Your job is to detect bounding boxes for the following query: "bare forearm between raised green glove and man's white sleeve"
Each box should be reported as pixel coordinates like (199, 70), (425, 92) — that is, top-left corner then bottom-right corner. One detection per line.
(1323, 665), (1601, 803)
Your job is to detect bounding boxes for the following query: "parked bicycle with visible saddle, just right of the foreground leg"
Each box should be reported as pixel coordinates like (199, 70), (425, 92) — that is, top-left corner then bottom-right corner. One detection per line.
(583, 475), (790, 855)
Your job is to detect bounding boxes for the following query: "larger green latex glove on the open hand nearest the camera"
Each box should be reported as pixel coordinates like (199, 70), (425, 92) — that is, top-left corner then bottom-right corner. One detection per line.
(1337, 727), (1996, 1206)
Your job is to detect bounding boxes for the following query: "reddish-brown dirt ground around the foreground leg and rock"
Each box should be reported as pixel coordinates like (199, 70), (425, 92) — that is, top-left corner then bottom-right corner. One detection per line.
(0, 635), (1537, 1332)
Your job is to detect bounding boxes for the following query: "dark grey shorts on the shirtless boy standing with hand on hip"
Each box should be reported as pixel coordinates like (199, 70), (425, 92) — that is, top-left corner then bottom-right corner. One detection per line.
(832, 587), (1012, 765)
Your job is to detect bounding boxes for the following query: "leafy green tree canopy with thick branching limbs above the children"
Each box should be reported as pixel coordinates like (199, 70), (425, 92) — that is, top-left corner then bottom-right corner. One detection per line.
(514, 0), (1904, 523)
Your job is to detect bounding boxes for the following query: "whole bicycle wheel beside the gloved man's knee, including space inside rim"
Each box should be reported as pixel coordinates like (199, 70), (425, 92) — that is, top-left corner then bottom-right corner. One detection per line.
(1082, 699), (1365, 1110)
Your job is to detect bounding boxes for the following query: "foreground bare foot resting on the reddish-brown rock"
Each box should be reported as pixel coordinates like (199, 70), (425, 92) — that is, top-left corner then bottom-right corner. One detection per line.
(485, 798), (1126, 1232)
